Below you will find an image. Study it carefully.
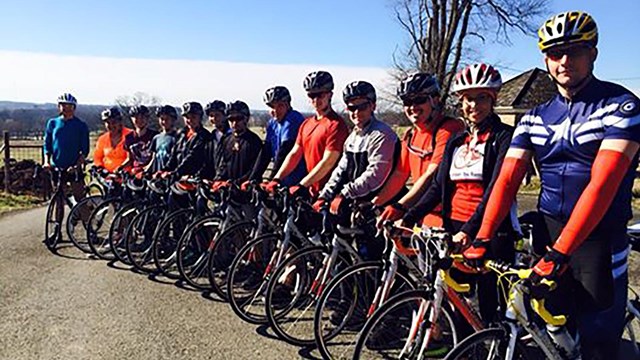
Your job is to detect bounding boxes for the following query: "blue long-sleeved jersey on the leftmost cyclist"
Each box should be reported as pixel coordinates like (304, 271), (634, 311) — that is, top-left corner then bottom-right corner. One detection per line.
(44, 115), (89, 168)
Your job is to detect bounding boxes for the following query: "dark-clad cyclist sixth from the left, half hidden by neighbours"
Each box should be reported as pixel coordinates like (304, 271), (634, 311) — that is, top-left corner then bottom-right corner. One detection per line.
(202, 100), (231, 179)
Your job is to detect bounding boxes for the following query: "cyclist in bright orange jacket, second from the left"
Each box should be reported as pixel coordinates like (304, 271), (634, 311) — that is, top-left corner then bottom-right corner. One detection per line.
(93, 106), (133, 172)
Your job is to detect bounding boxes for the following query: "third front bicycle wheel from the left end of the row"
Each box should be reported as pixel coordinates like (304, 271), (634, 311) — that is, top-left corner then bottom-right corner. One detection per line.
(87, 198), (123, 260)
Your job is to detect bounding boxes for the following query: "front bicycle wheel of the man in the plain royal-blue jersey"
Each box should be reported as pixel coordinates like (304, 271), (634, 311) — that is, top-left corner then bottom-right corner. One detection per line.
(207, 220), (256, 300)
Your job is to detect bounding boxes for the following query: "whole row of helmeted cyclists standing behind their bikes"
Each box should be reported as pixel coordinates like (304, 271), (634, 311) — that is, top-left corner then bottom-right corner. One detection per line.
(44, 11), (640, 359)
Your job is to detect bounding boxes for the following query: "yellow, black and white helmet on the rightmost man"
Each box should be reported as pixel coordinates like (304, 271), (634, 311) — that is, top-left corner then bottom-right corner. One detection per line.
(538, 11), (598, 52)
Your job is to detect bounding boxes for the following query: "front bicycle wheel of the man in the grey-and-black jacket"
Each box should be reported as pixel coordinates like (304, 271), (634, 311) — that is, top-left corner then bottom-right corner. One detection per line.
(265, 246), (351, 346)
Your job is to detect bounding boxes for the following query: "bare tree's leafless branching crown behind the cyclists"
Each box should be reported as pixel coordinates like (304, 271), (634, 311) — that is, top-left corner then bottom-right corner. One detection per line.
(392, 0), (548, 100)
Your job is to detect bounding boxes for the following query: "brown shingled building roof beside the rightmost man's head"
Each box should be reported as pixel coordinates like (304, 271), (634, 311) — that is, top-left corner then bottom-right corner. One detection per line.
(496, 68), (558, 109)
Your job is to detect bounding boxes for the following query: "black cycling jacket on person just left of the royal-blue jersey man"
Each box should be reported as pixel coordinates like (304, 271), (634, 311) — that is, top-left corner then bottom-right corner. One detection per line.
(216, 129), (262, 183)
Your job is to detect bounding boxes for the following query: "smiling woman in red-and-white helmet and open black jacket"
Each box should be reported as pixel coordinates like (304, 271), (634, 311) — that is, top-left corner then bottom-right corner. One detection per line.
(403, 63), (516, 324)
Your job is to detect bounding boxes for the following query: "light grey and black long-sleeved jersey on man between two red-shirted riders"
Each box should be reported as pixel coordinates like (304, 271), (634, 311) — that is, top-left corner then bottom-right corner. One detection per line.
(319, 117), (400, 200)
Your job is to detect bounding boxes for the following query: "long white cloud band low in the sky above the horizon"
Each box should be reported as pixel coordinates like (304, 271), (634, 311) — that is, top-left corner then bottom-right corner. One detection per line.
(0, 51), (389, 111)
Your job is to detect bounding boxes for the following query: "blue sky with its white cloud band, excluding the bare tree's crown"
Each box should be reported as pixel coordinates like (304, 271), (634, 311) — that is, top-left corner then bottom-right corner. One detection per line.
(0, 0), (640, 107)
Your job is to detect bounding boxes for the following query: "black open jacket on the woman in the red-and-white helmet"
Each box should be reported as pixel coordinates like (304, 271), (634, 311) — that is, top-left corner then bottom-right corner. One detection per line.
(403, 114), (514, 238)
